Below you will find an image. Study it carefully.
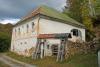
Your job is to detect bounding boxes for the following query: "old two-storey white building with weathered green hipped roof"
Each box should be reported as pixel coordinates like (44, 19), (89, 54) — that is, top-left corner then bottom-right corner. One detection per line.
(11, 6), (85, 56)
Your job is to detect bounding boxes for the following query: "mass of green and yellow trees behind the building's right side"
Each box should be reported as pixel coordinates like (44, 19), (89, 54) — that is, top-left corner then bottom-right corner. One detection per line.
(63, 0), (100, 41)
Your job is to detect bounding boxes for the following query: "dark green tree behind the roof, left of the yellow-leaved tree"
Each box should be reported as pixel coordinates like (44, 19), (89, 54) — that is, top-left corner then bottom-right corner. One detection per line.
(64, 0), (82, 22)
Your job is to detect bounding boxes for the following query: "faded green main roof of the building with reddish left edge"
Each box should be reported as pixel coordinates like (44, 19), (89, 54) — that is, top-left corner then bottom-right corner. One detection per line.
(15, 6), (84, 27)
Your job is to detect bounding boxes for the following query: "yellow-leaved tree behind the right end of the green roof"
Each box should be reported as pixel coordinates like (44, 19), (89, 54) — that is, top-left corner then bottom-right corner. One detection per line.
(81, 0), (93, 31)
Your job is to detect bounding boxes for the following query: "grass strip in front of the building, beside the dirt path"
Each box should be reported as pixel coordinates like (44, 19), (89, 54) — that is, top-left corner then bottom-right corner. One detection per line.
(6, 52), (98, 67)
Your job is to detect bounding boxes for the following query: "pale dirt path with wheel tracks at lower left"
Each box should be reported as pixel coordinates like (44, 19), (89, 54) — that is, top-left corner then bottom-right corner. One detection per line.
(0, 54), (36, 67)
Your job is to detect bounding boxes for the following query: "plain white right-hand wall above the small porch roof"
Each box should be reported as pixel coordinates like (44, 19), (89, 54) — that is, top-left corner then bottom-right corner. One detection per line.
(40, 18), (85, 41)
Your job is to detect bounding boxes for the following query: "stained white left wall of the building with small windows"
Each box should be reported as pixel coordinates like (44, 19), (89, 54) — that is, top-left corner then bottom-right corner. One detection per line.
(11, 18), (38, 55)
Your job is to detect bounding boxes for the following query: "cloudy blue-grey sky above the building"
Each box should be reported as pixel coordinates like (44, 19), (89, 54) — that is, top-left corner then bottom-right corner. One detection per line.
(0, 0), (66, 24)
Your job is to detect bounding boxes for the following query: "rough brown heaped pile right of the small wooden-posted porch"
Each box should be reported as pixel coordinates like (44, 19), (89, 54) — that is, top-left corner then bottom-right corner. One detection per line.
(65, 39), (100, 59)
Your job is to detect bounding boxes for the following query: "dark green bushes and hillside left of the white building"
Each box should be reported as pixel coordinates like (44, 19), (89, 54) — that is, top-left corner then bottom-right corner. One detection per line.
(0, 24), (13, 52)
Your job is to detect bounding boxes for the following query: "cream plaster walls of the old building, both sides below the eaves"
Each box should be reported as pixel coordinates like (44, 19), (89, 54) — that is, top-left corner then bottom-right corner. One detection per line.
(11, 16), (85, 56)
